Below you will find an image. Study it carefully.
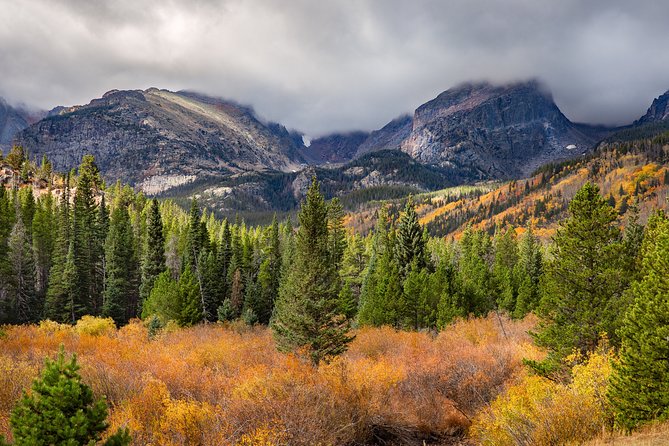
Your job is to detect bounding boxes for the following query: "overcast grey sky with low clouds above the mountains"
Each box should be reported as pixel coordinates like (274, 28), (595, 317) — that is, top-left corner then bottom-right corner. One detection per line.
(0, 0), (669, 136)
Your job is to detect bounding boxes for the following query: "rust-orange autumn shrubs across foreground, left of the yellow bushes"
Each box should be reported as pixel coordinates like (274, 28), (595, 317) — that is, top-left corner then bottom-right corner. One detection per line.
(0, 317), (541, 445)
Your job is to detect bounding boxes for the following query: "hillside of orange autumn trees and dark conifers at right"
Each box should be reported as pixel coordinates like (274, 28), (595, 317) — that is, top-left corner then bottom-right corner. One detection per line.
(348, 118), (669, 240)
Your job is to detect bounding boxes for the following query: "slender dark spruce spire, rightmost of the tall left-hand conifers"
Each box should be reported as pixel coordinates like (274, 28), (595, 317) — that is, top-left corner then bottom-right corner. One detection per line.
(138, 198), (167, 314)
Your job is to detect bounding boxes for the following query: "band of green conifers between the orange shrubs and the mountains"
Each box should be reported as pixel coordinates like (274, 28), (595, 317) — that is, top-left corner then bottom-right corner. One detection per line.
(0, 152), (669, 428)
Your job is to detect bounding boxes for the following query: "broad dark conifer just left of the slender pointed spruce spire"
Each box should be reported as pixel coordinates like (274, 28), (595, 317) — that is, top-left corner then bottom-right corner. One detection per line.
(102, 204), (139, 325)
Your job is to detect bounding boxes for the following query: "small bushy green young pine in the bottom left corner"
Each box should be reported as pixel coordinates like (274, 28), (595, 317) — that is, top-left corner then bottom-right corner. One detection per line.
(0, 347), (131, 446)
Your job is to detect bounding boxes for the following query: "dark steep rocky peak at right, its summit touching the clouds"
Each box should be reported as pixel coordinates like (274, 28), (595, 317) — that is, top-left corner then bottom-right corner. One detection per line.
(401, 81), (608, 179)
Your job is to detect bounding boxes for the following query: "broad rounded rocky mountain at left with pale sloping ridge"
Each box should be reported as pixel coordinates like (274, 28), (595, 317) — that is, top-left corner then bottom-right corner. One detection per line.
(15, 88), (304, 193)
